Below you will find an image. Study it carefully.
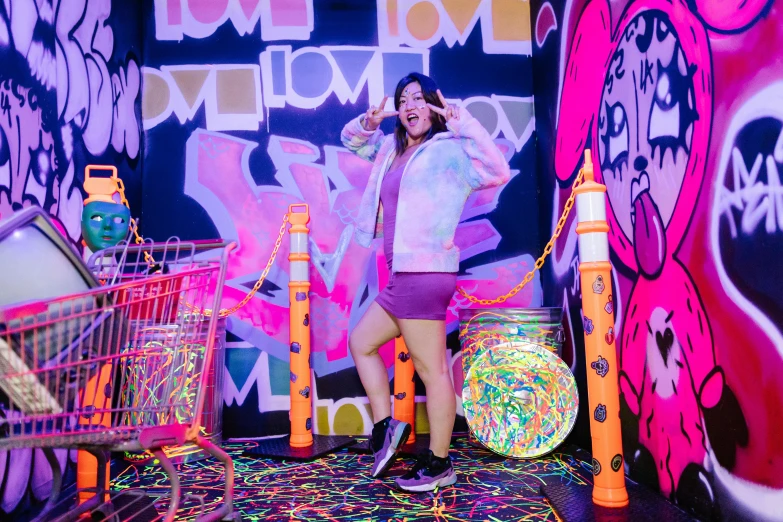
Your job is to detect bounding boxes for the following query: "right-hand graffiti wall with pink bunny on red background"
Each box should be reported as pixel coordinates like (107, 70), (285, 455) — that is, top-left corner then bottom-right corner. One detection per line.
(531, 0), (783, 520)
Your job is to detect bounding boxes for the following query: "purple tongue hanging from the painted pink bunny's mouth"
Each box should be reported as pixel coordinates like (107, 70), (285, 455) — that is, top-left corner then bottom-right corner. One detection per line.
(633, 190), (666, 278)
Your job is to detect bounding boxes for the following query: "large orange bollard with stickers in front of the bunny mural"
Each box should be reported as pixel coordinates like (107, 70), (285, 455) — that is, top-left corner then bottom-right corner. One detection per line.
(574, 150), (628, 507)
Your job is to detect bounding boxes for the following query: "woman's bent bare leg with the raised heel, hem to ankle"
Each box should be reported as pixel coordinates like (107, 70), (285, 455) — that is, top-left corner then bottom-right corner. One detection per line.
(348, 302), (400, 423)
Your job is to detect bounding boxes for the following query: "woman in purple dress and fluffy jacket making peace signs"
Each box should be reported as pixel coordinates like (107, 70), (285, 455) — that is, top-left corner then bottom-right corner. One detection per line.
(341, 73), (510, 491)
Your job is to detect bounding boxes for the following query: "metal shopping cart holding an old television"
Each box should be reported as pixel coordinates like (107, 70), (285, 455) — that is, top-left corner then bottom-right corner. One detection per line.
(0, 240), (236, 521)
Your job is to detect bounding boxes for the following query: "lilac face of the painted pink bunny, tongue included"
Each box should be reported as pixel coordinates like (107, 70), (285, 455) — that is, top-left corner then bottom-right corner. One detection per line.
(598, 11), (698, 276)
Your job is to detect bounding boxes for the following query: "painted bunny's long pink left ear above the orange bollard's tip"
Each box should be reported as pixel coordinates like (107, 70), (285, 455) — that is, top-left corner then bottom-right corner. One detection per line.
(555, 0), (612, 180)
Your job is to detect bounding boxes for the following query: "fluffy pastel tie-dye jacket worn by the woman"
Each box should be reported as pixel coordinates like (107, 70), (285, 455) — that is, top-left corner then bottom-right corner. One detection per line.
(341, 108), (511, 272)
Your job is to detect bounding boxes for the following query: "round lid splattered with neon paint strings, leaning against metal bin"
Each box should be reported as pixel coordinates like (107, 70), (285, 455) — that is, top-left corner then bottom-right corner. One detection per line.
(462, 342), (579, 458)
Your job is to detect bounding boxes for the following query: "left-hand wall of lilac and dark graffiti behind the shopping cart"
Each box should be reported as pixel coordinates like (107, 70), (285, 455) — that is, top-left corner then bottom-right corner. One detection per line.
(0, 0), (141, 519)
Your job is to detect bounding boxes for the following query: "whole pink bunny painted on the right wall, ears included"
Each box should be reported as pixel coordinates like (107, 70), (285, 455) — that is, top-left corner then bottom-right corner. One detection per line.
(555, 0), (768, 511)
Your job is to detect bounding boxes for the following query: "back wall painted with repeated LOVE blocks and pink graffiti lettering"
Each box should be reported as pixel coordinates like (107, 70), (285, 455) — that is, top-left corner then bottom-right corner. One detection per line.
(141, 0), (542, 437)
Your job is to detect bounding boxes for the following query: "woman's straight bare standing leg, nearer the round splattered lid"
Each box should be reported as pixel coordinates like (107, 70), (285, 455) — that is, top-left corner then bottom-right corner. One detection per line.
(398, 319), (457, 458)
